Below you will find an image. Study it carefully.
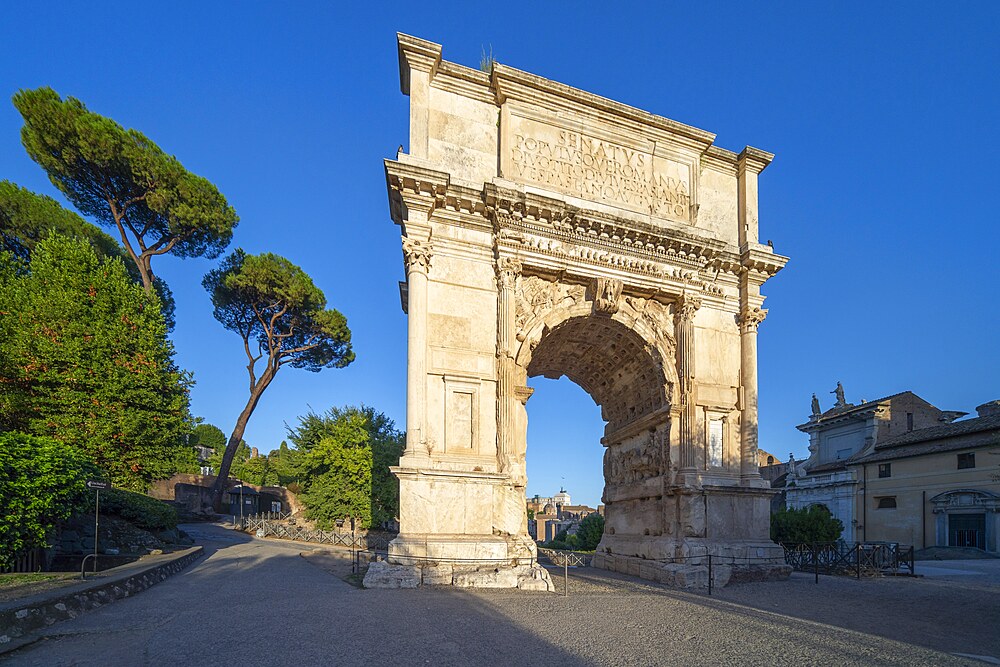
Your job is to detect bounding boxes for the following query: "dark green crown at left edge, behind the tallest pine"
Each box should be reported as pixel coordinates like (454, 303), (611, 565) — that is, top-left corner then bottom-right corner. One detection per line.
(0, 181), (174, 329)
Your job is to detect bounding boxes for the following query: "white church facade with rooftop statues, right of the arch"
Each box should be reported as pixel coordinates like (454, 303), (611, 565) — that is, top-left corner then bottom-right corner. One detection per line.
(785, 383), (966, 542)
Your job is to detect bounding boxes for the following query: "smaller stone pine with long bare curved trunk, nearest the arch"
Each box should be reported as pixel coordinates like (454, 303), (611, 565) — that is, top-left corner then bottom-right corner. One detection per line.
(202, 250), (354, 510)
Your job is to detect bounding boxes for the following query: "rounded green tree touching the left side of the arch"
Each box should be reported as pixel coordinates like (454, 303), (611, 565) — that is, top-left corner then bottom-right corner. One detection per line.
(289, 406), (405, 528)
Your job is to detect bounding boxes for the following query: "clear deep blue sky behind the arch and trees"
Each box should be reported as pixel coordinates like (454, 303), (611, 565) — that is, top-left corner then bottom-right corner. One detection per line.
(0, 2), (1000, 503)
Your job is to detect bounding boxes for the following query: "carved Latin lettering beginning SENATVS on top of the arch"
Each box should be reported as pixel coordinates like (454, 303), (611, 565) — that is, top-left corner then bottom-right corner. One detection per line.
(510, 130), (691, 221)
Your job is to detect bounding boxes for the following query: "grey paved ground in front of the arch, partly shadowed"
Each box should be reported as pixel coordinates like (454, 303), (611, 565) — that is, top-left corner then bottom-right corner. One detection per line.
(0, 525), (1000, 667)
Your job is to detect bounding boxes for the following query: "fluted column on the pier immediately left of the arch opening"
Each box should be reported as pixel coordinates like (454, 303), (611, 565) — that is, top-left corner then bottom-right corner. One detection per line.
(497, 257), (522, 481)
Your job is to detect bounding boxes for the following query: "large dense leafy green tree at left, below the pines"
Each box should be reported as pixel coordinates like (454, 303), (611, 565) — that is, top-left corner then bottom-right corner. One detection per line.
(0, 236), (193, 491)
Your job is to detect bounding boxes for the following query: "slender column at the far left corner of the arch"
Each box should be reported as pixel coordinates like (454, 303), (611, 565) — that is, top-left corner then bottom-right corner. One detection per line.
(403, 236), (432, 456)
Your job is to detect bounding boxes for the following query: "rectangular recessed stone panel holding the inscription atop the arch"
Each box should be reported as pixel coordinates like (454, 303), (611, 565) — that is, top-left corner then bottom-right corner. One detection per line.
(501, 111), (695, 222)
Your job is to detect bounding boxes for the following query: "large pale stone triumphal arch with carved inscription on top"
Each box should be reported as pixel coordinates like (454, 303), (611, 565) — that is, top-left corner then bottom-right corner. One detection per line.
(366, 35), (787, 589)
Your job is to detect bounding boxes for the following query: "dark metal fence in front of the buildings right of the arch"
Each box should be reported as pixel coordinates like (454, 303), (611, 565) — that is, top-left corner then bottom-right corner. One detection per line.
(781, 542), (915, 578)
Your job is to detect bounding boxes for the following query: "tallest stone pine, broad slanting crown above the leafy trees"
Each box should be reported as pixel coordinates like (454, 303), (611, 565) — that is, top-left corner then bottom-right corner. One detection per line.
(14, 88), (239, 292)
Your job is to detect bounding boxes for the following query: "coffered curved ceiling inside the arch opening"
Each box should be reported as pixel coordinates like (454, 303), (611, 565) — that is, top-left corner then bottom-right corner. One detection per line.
(528, 316), (668, 430)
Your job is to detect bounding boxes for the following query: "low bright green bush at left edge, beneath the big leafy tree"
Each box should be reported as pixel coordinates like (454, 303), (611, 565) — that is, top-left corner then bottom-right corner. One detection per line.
(0, 432), (96, 568)
